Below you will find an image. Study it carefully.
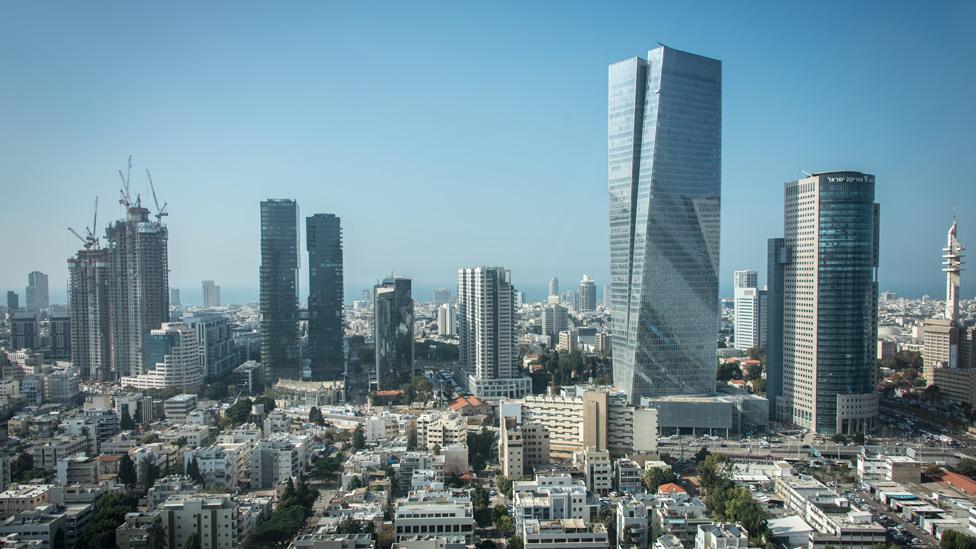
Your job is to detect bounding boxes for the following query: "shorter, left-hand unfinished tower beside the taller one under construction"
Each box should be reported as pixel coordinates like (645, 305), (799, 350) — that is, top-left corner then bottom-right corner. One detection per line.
(68, 248), (118, 381)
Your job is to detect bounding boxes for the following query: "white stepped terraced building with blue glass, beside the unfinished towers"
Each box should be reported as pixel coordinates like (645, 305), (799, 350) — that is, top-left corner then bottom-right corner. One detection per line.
(120, 322), (205, 392)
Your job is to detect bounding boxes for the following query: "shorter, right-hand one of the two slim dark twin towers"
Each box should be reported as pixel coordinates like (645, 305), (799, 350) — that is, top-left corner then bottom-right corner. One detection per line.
(305, 214), (348, 381)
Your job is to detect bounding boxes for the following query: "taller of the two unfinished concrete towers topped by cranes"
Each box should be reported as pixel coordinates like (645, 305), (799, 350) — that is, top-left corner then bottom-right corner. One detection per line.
(105, 201), (169, 376)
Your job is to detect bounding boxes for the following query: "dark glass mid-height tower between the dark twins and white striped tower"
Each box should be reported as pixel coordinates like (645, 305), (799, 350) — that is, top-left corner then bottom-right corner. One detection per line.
(373, 276), (415, 389)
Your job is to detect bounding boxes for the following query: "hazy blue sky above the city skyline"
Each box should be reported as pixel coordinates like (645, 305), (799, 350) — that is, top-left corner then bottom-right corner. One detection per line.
(0, 0), (976, 301)
